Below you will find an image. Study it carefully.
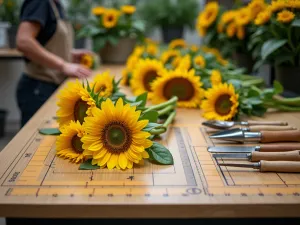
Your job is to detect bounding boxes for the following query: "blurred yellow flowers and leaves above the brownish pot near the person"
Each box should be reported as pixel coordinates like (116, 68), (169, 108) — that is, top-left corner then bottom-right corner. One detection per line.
(77, 5), (145, 52)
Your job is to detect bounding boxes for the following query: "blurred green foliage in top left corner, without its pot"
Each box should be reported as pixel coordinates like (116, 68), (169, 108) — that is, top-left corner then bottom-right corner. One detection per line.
(0, 0), (21, 25)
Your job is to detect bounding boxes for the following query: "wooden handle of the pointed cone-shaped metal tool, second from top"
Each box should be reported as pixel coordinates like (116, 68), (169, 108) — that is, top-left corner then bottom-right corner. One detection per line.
(261, 130), (300, 143)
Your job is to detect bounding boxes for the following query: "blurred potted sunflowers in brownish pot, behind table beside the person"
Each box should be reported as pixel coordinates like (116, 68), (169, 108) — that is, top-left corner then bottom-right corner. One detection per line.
(78, 5), (145, 64)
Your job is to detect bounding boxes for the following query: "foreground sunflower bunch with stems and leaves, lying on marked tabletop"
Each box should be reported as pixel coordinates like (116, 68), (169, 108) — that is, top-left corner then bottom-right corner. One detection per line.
(56, 72), (177, 170)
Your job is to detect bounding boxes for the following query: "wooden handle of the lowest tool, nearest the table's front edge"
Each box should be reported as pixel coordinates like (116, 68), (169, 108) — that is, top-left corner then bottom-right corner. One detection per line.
(260, 160), (300, 173)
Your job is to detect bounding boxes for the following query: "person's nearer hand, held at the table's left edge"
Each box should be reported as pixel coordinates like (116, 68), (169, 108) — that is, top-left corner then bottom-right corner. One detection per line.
(62, 62), (92, 79)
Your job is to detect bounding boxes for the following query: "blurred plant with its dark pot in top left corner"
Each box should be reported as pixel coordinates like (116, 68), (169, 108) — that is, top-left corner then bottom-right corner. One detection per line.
(0, 0), (20, 48)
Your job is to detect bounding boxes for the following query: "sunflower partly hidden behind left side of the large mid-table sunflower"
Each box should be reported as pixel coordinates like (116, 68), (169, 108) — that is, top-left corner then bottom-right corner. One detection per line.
(130, 59), (164, 95)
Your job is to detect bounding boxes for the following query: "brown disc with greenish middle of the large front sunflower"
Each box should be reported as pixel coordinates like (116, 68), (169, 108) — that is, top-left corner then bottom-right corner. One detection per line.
(103, 122), (131, 153)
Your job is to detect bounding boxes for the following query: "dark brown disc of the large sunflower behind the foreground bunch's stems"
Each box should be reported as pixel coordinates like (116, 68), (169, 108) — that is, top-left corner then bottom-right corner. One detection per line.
(164, 77), (195, 101)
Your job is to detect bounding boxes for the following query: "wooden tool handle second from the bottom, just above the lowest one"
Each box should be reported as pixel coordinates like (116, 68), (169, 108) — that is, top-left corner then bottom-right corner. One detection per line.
(251, 150), (300, 162)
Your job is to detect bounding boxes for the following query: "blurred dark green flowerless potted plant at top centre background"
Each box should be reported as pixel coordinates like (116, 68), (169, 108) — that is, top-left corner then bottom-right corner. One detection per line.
(139, 0), (199, 43)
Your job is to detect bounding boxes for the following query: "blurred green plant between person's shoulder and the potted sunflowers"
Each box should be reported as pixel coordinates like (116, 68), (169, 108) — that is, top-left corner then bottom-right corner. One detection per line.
(67, 0), (91, 48)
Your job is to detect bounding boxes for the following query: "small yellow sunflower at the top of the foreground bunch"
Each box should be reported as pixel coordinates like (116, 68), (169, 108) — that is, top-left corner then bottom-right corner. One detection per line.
(90, 71), (114, 98)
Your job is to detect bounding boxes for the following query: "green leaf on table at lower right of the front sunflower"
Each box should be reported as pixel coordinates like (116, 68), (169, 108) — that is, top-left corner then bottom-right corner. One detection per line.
(146, 142), (174, 165)
